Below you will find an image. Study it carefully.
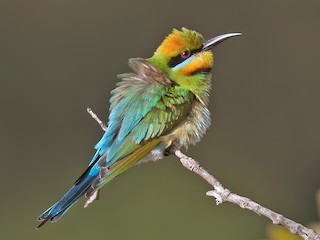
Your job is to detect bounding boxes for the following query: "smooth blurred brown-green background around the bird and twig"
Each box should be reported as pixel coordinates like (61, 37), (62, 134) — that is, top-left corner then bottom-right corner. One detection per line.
(0, 0), (320, 240)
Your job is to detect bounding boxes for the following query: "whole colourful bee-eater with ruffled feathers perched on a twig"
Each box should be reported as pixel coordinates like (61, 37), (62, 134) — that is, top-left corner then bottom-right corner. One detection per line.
(38, 28), (241, 227)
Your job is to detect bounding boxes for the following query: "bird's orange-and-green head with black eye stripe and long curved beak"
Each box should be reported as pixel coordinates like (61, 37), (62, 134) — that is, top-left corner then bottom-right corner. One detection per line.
(149, 28), (241, 101)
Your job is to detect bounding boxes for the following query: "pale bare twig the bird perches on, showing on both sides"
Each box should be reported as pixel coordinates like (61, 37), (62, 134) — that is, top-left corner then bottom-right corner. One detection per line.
(87, 108), (320, 240)
